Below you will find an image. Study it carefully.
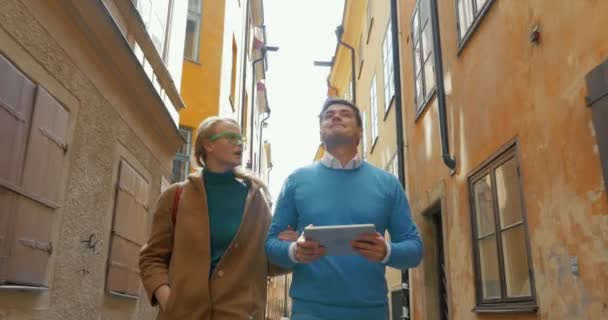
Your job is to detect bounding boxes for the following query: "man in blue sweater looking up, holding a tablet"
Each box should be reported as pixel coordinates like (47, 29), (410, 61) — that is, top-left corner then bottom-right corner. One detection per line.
(266, 100), (422, 320)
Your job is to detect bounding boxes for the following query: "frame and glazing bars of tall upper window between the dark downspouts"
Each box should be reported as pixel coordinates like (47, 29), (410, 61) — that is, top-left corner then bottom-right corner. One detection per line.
(410, 0), (437, 120)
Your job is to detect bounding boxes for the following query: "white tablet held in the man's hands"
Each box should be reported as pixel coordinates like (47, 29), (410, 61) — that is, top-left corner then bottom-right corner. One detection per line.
(304, 224), (376, 256)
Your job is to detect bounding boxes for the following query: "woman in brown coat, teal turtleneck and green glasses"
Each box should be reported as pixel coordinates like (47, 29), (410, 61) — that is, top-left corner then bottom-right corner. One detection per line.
(139, 117), (295, 320)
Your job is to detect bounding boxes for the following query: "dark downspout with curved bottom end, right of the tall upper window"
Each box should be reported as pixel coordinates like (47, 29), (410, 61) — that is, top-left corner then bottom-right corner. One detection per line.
(430, 0), (456, 173)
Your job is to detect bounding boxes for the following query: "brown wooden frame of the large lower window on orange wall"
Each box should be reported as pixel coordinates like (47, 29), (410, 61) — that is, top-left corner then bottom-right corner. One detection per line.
(467, 140), (538, 313)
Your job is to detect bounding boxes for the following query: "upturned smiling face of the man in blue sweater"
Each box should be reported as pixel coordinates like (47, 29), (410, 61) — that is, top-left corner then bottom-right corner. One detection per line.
(320, 104), (362, 145)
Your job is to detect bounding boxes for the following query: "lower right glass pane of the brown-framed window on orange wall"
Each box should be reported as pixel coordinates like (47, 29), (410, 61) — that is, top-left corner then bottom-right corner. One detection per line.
(502, 224), (532, 297)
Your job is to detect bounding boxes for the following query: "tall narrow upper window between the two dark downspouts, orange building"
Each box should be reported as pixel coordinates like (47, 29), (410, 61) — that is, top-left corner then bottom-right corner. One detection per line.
(412, 0), (435, 113)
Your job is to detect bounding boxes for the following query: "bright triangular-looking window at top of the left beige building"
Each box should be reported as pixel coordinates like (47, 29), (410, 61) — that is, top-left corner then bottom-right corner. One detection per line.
(134, 0), (171, 57)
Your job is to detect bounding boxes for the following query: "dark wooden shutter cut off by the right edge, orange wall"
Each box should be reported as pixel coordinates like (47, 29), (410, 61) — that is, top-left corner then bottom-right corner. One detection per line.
(586, 60), (608, 194)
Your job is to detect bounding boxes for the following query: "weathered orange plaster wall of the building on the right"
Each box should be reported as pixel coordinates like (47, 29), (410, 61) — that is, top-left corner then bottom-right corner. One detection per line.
(400, 0), (608, 319)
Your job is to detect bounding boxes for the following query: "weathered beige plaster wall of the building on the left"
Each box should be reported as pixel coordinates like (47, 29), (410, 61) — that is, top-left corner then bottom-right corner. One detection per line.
(0, 0), (177, 320)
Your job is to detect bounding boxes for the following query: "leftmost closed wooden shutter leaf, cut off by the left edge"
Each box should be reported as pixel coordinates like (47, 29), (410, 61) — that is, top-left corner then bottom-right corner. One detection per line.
(0, 55), (36, 285)
